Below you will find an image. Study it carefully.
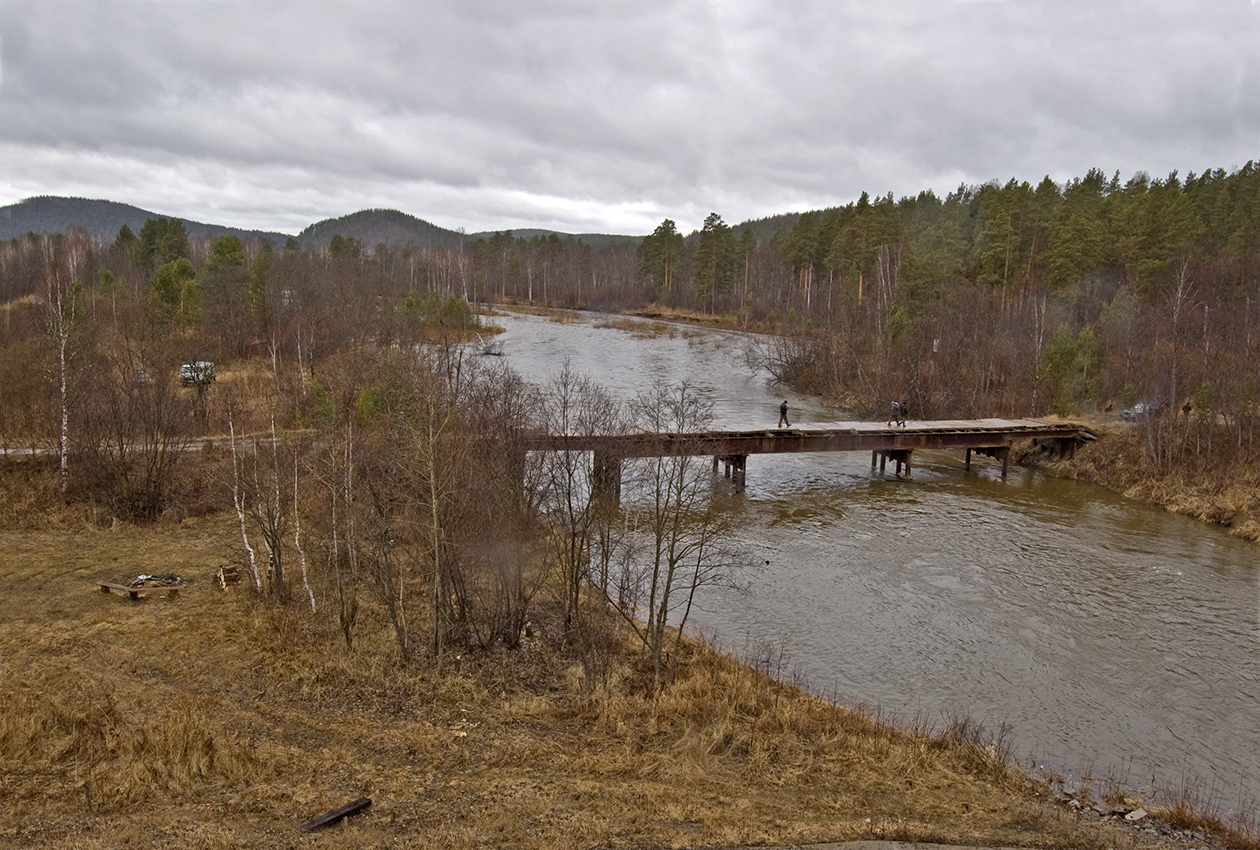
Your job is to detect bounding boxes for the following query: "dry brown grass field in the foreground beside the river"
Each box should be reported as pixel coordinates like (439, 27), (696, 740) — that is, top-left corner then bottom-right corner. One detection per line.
(0, 465), (1239, 850)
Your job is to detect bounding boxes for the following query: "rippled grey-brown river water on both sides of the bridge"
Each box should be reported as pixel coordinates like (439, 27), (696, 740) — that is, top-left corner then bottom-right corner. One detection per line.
(483, 307), (1260, 812)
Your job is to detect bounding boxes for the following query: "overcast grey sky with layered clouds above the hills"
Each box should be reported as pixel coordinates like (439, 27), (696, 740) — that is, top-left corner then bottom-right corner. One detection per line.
(0, 0), (1260, 234)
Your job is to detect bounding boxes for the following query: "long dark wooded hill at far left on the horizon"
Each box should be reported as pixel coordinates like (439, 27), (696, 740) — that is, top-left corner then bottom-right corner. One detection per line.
(0, 196), (289, 244)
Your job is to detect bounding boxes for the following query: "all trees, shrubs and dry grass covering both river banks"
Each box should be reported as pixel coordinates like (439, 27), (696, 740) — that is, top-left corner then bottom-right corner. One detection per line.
(0, 164), (1260, 847)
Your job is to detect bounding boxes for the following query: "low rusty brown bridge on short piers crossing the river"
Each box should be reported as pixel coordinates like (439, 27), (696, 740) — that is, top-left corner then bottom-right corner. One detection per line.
(527, 419), (1096, 497)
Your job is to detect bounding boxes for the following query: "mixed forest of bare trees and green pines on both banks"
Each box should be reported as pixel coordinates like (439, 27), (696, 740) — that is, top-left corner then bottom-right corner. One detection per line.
(0, 164), (1260, 659)
